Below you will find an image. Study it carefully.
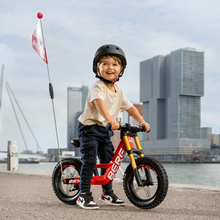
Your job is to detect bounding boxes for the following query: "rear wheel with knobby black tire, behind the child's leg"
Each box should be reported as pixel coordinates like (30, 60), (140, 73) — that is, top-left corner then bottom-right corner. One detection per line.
(52, 158), (82, 205)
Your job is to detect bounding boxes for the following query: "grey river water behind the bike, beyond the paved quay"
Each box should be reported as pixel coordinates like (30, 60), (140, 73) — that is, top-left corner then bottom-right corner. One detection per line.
(0, 162), (220, 187)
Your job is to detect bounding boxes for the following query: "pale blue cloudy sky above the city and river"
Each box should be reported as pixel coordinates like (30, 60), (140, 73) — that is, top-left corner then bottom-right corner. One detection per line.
(0, 0), (220, 152)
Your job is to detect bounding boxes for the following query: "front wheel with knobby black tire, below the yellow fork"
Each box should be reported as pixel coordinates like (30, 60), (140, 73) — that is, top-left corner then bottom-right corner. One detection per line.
(123, 157), (169, 209)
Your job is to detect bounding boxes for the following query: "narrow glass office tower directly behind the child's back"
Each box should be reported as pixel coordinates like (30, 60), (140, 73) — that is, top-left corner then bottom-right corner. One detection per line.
(67, 86), (89, 156)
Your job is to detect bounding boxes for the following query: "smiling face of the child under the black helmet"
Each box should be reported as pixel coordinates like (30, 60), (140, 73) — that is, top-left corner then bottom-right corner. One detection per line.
(97, 57), (122, 81)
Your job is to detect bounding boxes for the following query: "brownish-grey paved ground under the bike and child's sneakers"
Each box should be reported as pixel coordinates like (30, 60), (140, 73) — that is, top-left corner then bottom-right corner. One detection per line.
(0, 171), (220, 220)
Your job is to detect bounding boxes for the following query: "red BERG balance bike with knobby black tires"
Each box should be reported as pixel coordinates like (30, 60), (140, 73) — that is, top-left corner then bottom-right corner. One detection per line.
(52, 124), (168, 209)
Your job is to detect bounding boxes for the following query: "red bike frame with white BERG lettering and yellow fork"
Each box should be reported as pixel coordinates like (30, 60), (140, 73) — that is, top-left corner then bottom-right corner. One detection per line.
(71, 135), (144, 185)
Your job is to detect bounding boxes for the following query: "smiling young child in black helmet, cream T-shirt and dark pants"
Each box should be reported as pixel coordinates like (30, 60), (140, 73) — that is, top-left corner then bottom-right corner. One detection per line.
(77, 44), (150, 209)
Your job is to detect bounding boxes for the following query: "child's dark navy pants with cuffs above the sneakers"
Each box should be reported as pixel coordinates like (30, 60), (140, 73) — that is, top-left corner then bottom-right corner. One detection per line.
(78, 122), (114, 193)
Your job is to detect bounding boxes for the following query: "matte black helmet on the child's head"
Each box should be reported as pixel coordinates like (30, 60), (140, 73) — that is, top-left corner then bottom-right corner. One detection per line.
(93, 44), (127, 83)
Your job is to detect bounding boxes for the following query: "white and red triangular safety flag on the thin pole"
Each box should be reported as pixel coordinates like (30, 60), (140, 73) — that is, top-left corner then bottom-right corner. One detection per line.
(31, 20), (48, 63)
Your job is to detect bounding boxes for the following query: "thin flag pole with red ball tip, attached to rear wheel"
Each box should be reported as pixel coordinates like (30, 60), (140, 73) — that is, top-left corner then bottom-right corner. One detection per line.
(37, 12), (63, 172)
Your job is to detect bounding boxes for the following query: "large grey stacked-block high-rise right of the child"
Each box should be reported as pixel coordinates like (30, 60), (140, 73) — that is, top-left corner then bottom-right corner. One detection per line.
(140, 48), (208, 158)
